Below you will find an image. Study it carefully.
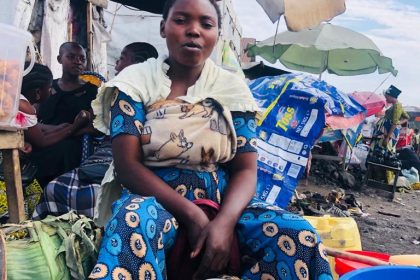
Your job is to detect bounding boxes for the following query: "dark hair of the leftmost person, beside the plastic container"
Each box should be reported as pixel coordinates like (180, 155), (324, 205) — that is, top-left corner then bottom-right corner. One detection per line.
(21, 62), (53, 97)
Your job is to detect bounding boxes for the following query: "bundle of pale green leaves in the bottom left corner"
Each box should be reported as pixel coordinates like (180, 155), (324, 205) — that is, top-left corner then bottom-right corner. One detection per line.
(0, 212), (101, 280)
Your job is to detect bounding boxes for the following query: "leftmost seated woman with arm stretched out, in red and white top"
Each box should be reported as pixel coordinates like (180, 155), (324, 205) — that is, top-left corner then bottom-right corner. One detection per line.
(0, 63), (89, 221)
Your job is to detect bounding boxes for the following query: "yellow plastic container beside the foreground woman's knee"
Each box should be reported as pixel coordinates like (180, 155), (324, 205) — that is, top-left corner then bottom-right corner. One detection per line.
(304, 216), (362, 279)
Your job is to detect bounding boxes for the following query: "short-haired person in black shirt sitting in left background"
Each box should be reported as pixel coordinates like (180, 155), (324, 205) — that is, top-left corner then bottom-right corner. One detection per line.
(31, 42), (99, 186)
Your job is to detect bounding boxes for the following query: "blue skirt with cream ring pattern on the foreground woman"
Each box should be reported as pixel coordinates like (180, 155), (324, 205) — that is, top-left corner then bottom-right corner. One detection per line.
(90, 168), (332, 280)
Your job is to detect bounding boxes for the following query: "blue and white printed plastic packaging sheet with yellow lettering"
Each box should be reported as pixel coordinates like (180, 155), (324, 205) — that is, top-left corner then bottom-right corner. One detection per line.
(249, 75), (325, 208)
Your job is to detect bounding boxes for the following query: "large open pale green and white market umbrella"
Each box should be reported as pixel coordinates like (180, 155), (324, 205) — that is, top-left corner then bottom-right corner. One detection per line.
(247, 24), (398, 76)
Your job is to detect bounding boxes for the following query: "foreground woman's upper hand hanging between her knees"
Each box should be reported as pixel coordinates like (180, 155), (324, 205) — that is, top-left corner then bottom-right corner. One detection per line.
(191, 216), (235, 279)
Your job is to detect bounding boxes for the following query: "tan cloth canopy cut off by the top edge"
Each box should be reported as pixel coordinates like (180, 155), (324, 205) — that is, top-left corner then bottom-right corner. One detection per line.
(257, 0), (346, 31)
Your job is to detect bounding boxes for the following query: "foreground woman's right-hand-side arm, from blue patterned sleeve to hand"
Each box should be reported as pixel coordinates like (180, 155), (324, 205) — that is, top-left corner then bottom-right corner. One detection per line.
(191, 110), (257, 279)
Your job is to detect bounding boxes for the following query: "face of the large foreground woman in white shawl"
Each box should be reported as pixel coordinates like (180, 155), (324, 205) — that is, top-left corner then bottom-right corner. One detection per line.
(161, 0), (219, 67)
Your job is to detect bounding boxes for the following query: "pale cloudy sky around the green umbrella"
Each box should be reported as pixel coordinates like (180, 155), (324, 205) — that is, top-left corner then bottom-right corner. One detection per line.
(232, 0), (420, 107)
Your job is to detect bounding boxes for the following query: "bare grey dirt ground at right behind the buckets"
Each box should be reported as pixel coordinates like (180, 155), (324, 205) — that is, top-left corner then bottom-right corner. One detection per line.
(297, 177), (420, 255)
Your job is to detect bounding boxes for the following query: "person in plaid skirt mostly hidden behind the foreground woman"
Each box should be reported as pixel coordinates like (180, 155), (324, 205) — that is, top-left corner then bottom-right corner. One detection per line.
(32, 42), (157, 220)
